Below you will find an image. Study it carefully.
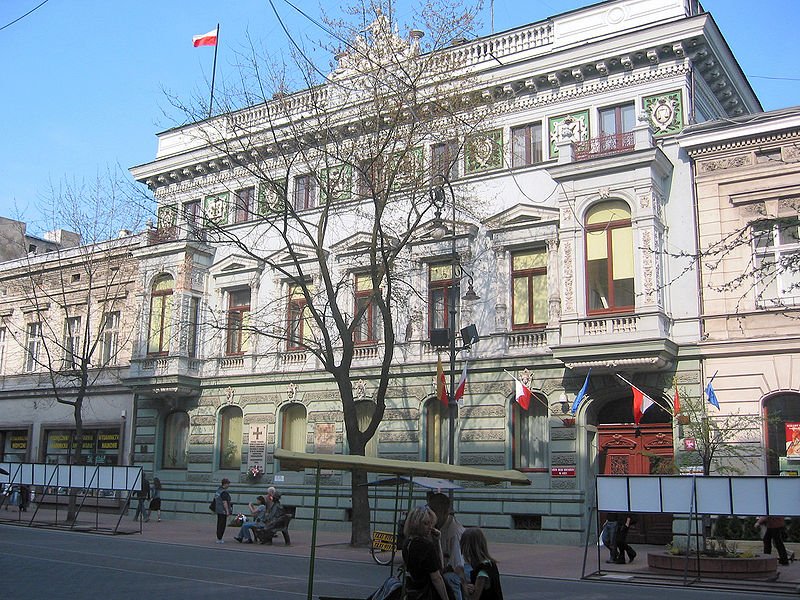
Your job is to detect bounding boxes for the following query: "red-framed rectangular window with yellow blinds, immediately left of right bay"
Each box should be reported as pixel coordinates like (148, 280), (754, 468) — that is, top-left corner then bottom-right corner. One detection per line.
(511, 248), (548, 329)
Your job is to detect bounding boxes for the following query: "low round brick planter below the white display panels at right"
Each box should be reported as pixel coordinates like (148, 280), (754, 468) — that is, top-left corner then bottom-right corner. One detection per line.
(647, 552), (778, 579)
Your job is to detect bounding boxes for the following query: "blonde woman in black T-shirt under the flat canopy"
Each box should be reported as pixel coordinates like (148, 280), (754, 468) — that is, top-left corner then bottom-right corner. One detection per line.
(403, 506), (448, 600)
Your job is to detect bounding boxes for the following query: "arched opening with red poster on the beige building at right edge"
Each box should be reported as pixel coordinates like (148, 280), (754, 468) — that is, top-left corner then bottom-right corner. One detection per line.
(764, 393), (800, 475)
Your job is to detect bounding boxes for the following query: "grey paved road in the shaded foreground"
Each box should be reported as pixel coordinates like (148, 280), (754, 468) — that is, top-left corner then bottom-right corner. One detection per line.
(0, 525), (792, 600)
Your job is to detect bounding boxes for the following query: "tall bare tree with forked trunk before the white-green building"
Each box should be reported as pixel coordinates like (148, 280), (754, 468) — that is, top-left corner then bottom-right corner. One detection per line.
(159, 2), (491, 545)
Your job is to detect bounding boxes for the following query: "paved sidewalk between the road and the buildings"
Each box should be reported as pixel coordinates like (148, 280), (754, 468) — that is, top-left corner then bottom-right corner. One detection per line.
(0, 511), (800, 592)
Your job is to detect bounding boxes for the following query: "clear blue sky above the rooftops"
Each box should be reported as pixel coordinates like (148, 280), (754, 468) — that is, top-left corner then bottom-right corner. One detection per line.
(0, 0), (800, 230)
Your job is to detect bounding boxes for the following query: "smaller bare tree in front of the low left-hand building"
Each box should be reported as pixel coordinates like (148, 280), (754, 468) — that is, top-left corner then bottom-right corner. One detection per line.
(0, 176), (145, 520)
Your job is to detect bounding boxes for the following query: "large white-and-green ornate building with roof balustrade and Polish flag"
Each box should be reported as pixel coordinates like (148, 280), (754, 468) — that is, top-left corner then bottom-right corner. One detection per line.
(127, 0), (761, 543)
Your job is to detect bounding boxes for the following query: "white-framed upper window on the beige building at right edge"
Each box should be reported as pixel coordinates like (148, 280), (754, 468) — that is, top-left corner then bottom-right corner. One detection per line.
(752, 216), (800, 308)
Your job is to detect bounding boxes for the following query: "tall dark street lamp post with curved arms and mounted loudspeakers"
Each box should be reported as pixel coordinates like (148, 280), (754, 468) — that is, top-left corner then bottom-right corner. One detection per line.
(430, 175), (480, 465)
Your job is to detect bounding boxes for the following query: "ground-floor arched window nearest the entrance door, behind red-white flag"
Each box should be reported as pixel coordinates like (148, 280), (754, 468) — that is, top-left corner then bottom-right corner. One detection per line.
(511, 393), (550, 471)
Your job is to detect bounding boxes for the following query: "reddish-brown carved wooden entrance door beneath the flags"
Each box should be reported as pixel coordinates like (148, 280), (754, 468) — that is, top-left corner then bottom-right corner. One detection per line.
(597, 423), (674, 544)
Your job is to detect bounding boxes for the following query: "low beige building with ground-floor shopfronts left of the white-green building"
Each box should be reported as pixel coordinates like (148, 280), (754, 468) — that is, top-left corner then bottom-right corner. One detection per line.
(0, 234), (139, 474)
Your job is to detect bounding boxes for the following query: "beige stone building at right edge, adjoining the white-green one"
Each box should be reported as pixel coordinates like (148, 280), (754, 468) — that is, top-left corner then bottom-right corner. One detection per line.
(680, 107), (800, 476)
